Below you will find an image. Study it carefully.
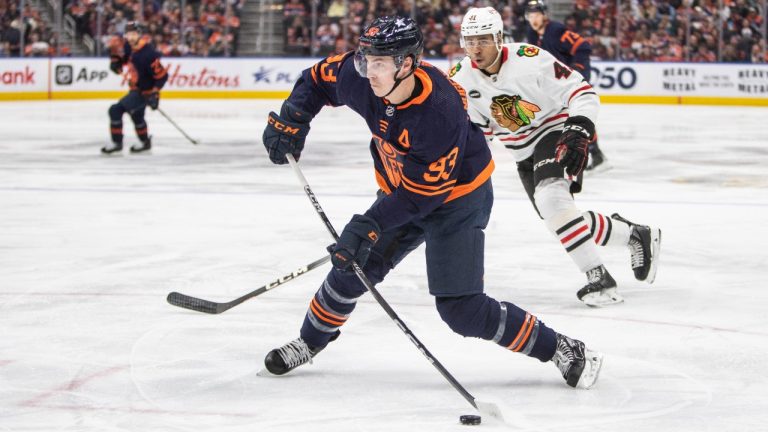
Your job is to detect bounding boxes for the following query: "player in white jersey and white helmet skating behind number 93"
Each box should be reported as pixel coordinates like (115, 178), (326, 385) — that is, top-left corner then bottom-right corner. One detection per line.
(450, 7), (661, 306)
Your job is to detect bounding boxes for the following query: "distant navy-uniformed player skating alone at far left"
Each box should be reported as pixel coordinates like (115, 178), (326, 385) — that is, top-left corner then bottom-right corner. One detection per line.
(101, 22), (168, 154)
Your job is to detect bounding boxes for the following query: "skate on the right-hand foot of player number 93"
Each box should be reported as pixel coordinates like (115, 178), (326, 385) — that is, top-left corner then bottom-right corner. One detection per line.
(552, 333), (603, 389)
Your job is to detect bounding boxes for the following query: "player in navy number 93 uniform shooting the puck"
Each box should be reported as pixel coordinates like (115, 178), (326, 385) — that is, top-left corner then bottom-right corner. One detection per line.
(263, 17), (602, 388)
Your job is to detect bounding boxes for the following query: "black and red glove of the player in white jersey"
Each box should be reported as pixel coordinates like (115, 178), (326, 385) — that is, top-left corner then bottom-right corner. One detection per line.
(555, 116), (595, 177)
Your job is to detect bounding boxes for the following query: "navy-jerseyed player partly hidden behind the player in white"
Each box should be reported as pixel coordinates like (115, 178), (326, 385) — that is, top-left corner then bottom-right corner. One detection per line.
(525, 0), (608, 171)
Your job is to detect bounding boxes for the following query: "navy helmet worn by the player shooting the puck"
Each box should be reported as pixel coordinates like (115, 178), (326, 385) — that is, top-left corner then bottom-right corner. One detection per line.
(355, 16), (424, 76)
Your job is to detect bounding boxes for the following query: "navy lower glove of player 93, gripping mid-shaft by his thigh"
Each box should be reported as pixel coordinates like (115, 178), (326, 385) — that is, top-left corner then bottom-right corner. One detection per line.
(328, 215), (381, 271)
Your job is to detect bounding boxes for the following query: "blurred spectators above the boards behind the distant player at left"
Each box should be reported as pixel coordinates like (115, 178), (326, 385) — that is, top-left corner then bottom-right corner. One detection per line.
(65, 0), (243, 57)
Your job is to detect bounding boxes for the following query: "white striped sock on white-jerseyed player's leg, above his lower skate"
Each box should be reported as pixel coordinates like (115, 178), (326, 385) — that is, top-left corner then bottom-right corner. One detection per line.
(544, 205), (603, 273)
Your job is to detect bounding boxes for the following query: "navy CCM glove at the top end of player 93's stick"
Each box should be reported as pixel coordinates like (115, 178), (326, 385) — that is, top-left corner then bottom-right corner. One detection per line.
(261, 101), (312, 165)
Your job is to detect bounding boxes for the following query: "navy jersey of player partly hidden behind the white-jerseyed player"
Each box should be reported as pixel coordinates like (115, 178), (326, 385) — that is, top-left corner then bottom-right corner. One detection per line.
(527, 21), (592, 81)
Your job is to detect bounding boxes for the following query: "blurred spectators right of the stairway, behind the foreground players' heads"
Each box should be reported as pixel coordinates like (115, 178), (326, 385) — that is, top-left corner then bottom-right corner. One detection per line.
(283, 0), (766, 63)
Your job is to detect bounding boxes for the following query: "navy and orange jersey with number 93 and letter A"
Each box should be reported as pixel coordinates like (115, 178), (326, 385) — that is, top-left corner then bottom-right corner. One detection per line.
(288, 52), (494, 230)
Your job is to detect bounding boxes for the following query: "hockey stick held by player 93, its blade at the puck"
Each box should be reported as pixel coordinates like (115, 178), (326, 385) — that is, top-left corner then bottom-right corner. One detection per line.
(286, 153), (504, 421)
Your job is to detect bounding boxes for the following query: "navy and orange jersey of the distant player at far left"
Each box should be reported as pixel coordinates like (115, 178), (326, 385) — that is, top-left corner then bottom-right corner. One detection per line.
(111, 36), (168, 93)
